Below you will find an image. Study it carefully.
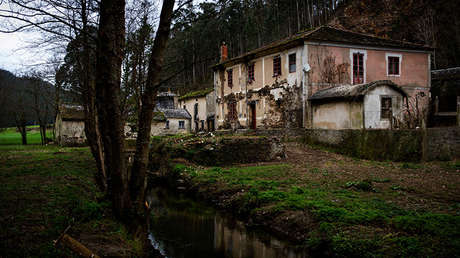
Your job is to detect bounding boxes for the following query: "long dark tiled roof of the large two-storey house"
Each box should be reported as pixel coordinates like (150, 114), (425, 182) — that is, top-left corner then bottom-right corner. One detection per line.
(213, 26), (433, 68)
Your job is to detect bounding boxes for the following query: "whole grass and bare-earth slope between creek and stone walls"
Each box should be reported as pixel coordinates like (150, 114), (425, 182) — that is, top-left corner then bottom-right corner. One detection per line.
(175, 143), (460, 257)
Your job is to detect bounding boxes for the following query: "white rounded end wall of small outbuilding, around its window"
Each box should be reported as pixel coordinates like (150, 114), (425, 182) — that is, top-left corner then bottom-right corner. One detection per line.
(364, 86), (403, 128)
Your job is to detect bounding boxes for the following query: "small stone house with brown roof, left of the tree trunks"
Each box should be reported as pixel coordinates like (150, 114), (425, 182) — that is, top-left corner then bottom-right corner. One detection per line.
(55, 104), (86, 146)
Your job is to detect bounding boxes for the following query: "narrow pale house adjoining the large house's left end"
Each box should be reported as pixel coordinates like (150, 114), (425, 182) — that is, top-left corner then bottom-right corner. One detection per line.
(179, 88), (216, 132)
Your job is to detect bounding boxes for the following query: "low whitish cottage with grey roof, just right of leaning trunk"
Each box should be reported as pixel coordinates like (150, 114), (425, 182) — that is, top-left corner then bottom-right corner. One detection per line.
(151, 92), (192, 135)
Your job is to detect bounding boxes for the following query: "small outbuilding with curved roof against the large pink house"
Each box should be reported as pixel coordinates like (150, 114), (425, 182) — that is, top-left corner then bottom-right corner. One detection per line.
(308, 80), (407, 130)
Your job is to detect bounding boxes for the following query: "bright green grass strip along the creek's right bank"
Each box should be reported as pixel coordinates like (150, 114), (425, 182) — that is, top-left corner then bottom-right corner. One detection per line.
(174, 164), (460, 257)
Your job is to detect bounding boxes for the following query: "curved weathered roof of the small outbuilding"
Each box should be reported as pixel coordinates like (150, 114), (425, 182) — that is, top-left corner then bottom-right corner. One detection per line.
(308, 80), (407, 100)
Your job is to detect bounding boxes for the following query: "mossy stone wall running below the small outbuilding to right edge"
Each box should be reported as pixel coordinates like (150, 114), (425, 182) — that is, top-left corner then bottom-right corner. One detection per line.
(303, 127), (460, 162)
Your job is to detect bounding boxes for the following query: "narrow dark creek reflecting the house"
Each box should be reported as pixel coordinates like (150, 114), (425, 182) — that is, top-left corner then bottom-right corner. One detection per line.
(148, 188), (308, 258)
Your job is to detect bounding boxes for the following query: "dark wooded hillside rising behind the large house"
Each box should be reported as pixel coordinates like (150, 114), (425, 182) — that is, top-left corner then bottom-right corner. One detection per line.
(163, 0), (460, 93)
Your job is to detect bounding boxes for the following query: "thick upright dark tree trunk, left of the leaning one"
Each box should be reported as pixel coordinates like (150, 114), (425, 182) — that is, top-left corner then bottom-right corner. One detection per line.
(96, 0), (132, 222)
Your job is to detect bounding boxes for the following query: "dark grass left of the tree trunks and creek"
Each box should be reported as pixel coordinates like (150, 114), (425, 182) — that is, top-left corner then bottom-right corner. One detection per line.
(0, 145), (134, 257)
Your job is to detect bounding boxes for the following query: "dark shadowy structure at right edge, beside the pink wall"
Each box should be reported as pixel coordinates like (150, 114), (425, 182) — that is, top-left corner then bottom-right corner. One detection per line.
(430, 67), (460, 126)
